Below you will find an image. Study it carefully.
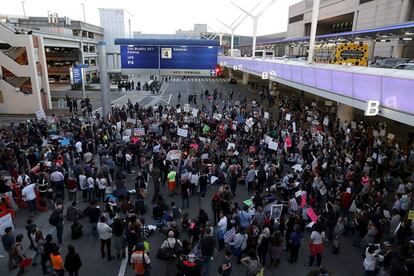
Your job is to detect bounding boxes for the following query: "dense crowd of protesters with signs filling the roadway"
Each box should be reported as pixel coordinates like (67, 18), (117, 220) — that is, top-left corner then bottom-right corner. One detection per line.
(0, 82), (414, 276)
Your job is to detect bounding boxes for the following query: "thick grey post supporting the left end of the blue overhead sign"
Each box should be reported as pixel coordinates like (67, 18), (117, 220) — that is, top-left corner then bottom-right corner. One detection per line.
(98, 41), (110, 118)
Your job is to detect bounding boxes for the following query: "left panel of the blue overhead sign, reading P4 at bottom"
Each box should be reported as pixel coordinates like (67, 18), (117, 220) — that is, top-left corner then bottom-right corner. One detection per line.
(121, 46), (158, 69)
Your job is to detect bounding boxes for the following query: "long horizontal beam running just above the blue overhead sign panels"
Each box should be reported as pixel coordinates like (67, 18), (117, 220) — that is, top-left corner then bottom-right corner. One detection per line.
(115, 38), (220, 46)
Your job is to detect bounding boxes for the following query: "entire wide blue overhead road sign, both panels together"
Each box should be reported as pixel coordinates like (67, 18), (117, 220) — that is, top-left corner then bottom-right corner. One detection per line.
(121, 45), (218, 70)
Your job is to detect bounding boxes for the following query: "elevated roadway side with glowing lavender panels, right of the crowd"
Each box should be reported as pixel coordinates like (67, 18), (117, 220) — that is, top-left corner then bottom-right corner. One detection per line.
(219, 56), (414, 126)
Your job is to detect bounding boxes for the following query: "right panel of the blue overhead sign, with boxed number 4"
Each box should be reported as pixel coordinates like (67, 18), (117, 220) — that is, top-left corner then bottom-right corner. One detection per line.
(161, 46), (217, 70)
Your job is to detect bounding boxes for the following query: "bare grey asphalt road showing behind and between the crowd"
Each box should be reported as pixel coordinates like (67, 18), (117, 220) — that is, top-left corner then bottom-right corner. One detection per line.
(0, 76), (363, 276)
